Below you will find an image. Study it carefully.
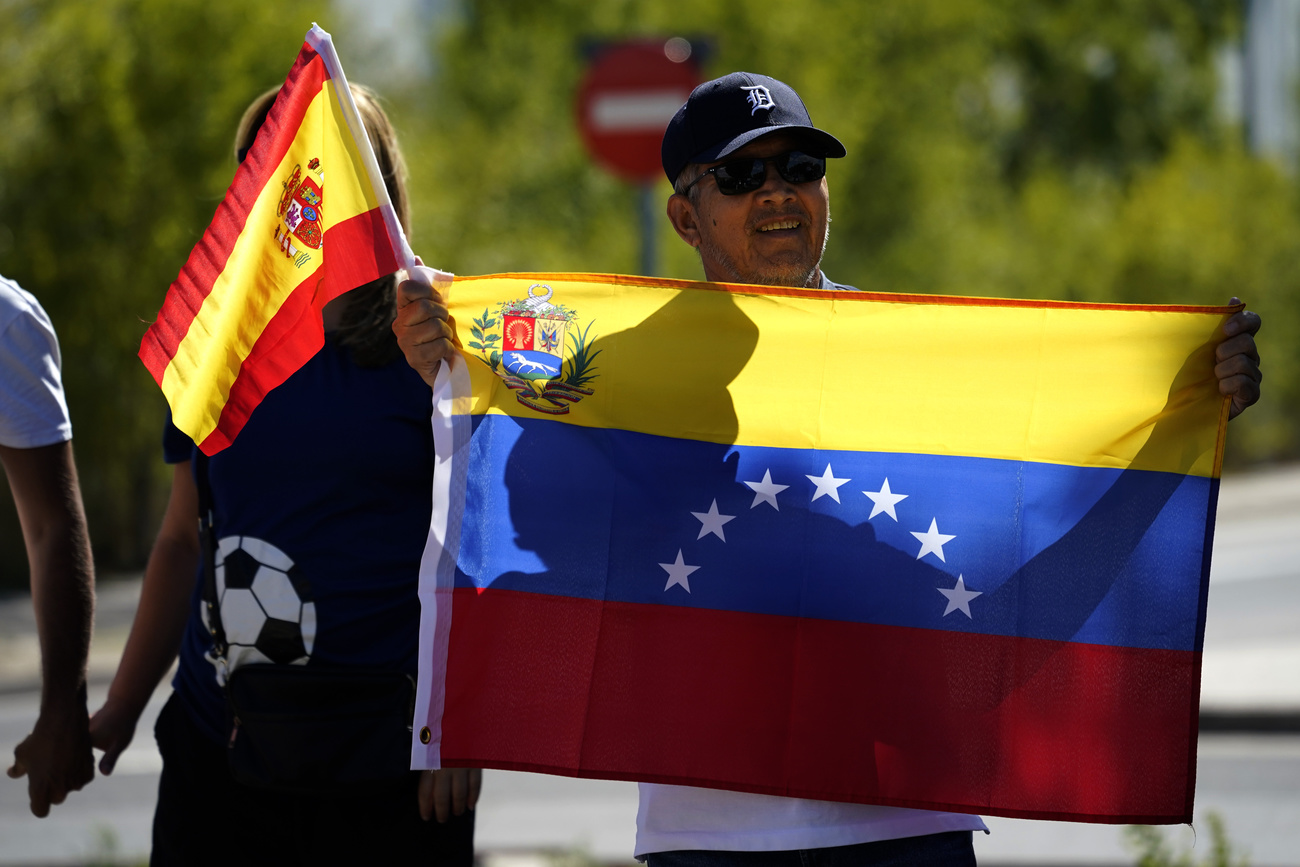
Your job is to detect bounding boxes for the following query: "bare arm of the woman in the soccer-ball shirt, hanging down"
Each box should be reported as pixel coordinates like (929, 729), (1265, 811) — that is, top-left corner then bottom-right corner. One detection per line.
(90, 461), (199, 773)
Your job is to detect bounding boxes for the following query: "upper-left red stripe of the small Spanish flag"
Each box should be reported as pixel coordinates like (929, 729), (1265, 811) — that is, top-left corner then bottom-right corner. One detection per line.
(139, 44), (329, 385)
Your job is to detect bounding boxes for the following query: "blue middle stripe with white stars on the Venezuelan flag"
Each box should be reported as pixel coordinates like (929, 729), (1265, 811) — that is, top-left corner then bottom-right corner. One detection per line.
(456, 415), (1218, 650)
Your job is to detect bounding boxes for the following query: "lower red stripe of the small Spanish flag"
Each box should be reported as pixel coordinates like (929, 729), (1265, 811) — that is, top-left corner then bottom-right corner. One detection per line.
(199, 208), (398, 455)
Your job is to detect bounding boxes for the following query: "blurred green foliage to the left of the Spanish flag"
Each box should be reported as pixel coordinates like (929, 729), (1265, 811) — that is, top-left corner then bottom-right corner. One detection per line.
(0, 0), (312, 584)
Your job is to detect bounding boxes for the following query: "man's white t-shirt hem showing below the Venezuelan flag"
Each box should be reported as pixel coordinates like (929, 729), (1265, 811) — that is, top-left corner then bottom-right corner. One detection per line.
(636, 783), (988, 858)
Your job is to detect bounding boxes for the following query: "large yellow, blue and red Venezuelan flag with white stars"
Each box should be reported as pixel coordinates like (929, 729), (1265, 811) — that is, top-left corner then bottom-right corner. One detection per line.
(412, 274), (1232, 823)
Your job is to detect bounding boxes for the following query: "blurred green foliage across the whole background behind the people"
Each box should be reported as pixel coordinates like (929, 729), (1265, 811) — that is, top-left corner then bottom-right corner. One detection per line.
(0, 0), (1300, 586)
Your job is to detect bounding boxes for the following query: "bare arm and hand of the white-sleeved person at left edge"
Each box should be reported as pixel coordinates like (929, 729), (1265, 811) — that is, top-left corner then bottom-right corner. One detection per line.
(0, 442), (95, 816)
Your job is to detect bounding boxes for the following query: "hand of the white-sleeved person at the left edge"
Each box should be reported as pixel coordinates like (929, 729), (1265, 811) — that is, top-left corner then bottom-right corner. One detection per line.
(9, 697), (95, 818)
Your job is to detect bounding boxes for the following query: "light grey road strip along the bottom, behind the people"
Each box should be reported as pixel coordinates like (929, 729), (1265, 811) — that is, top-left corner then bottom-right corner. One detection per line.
(0, 689), (1300, 867)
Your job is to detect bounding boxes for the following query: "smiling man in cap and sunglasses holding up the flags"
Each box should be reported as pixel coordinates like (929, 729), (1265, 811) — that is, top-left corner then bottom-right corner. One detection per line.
(394, 73), (1260, 867)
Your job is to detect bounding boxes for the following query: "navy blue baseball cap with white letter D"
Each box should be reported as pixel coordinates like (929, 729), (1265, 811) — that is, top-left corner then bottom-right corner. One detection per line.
(659, 73), (845, 182)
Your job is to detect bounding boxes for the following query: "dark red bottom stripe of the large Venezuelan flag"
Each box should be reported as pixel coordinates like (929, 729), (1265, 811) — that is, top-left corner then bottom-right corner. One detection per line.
(441, 589), (1200, 823)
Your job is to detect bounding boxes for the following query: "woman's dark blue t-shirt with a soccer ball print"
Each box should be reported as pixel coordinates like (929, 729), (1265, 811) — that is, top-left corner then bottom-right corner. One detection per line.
(164, 342), (433, 740)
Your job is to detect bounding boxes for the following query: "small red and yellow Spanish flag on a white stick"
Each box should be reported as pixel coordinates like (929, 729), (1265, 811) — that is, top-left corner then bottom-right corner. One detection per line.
(139, 25), (413, 455)
